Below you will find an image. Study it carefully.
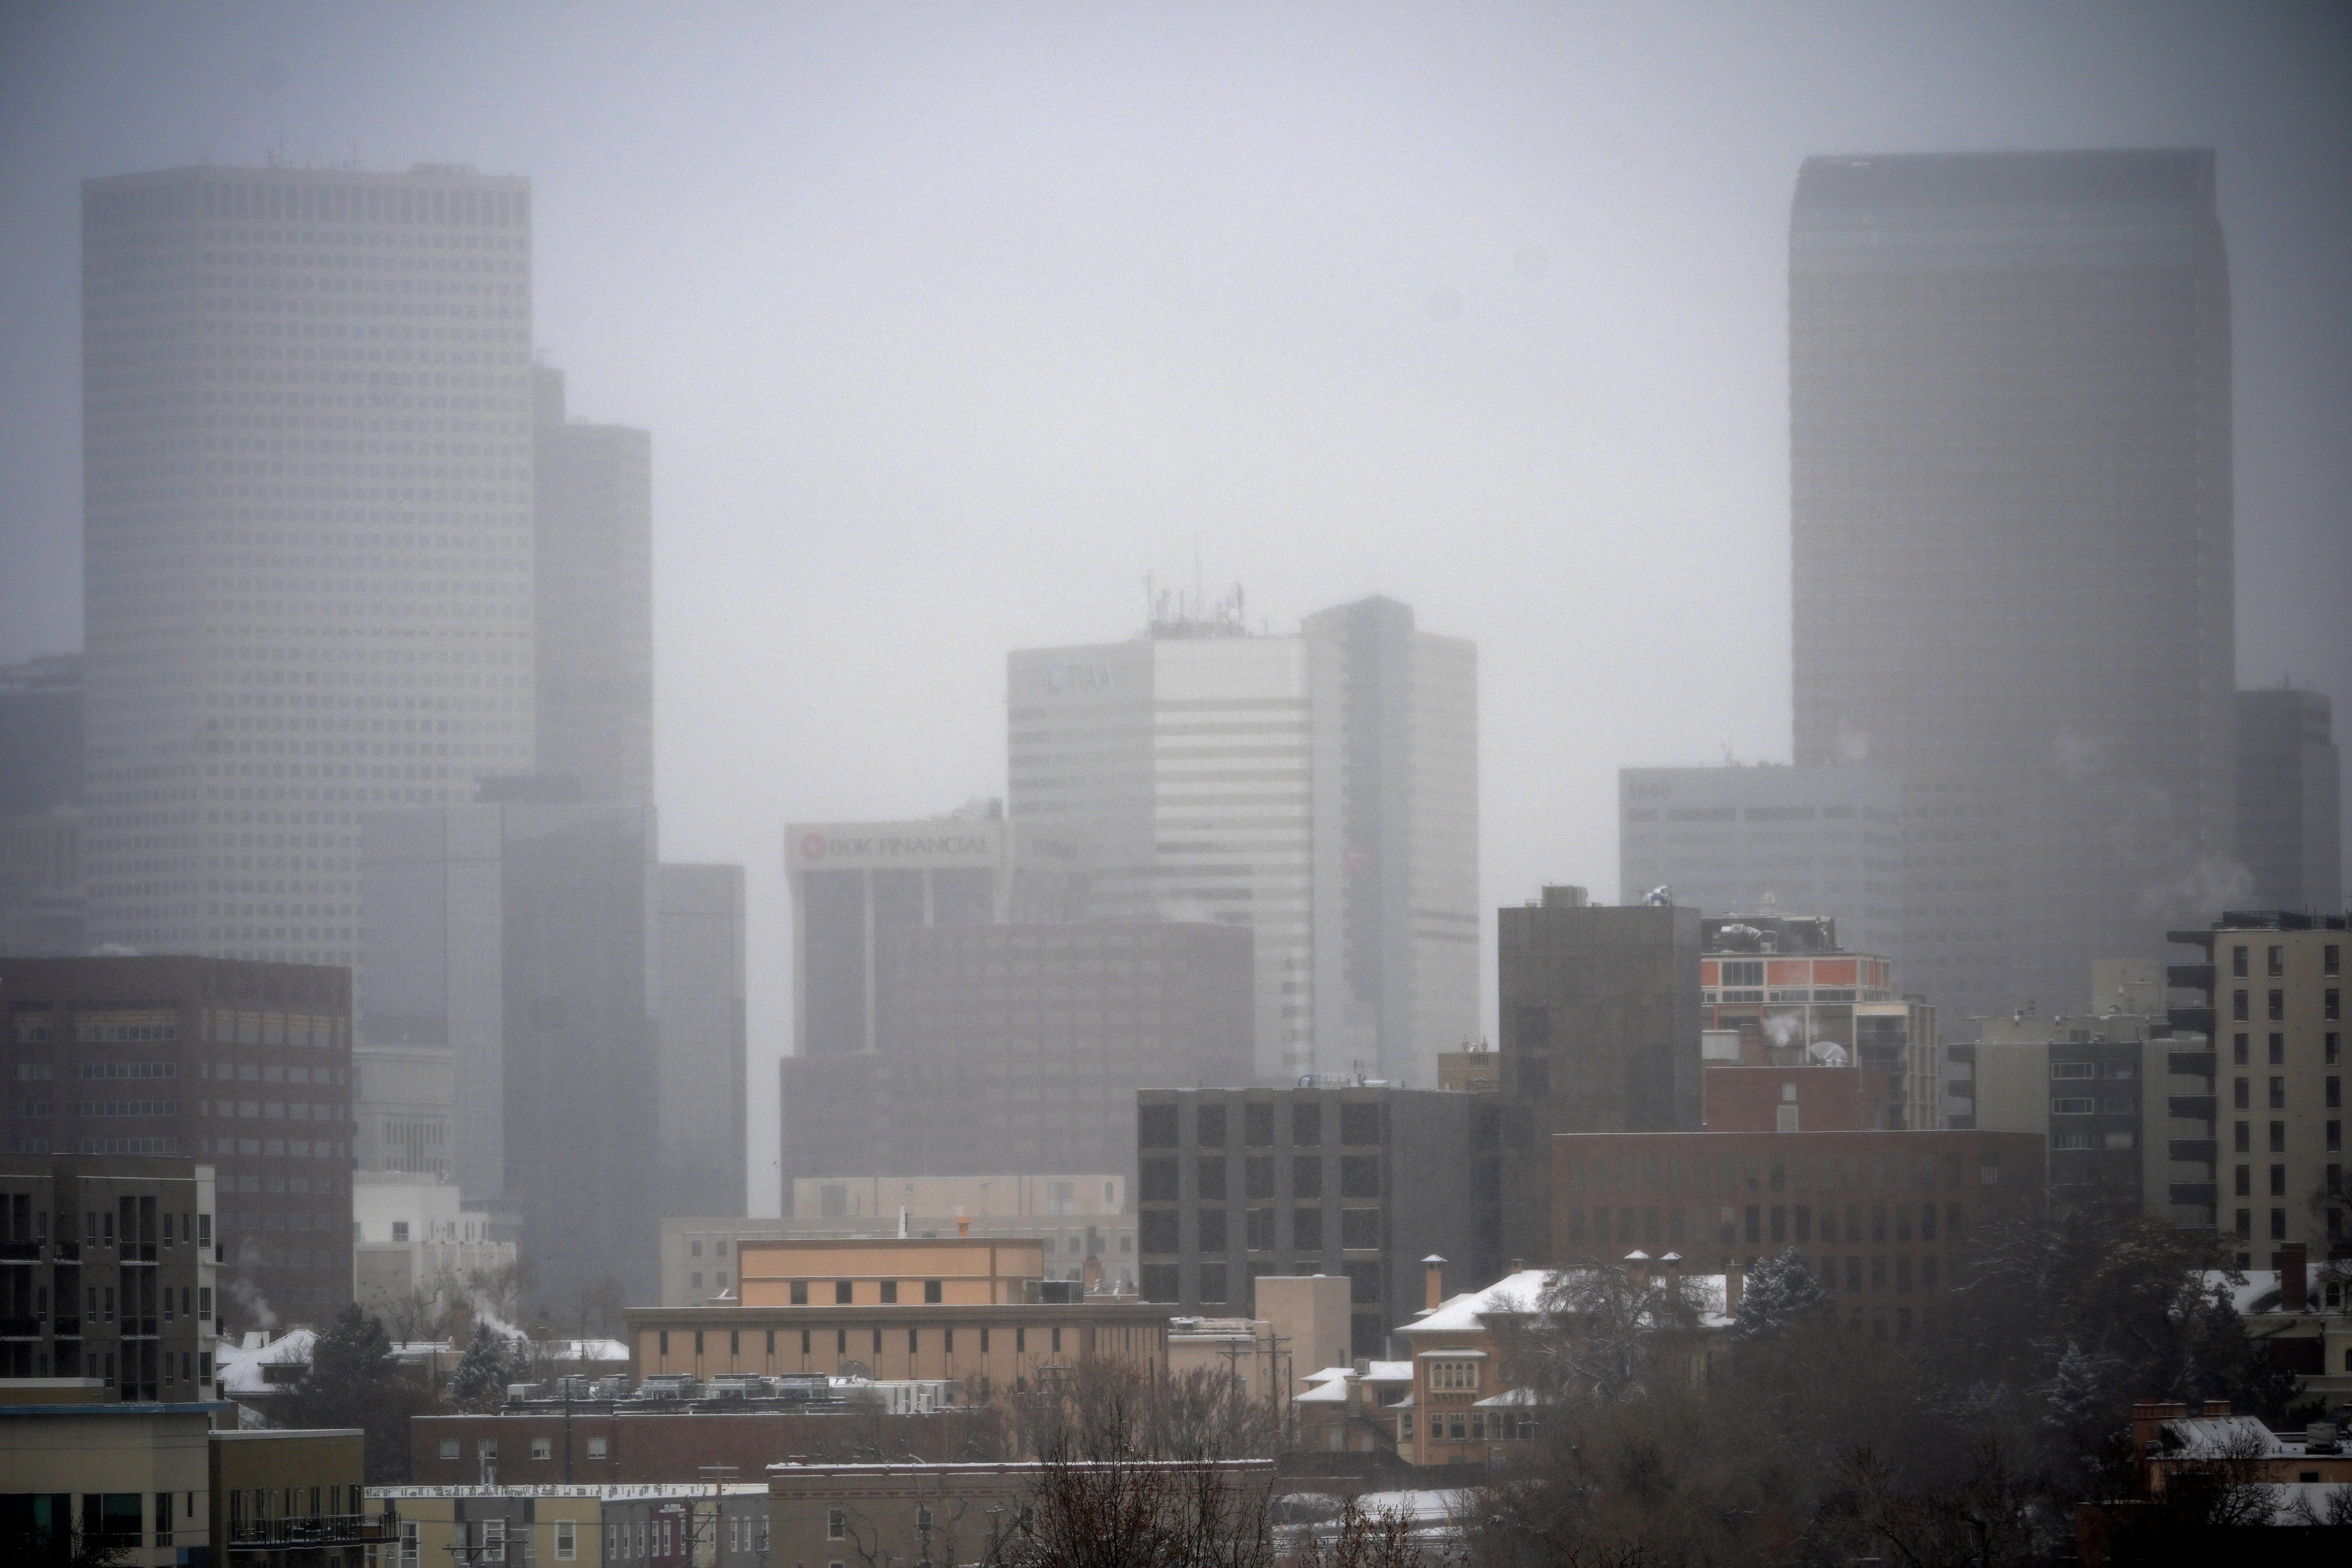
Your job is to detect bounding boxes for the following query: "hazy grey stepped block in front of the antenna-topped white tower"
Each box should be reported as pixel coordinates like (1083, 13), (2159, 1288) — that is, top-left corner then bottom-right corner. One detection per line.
(783, 922), (1251, 1182)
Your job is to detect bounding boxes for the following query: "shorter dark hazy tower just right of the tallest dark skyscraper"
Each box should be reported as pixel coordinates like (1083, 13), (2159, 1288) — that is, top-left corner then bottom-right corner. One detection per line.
(2237, 686), (2343, 912)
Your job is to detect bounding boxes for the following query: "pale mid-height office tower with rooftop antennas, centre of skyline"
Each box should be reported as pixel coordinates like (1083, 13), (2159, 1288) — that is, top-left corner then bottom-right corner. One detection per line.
(1007, 599), (1479, 1084)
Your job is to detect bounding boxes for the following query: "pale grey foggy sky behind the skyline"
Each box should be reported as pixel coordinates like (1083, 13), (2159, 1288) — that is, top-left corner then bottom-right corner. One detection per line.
(0, 5), (2352, 1213)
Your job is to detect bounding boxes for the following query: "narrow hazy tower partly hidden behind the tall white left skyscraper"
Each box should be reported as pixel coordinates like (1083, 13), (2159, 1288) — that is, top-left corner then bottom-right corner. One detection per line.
(534, 367), (654, 806)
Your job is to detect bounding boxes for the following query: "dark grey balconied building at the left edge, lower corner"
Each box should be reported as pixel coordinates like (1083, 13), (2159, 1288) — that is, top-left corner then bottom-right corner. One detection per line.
(0, 1154), (221, 1401)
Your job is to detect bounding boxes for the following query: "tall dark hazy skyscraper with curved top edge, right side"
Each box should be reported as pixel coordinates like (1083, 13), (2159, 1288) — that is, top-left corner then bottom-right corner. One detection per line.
(1790, 151), (2237, 1018)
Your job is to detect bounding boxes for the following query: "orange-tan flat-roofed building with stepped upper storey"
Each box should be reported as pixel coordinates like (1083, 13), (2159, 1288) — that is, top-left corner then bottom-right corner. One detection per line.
(628, 1236), (1169, 1399)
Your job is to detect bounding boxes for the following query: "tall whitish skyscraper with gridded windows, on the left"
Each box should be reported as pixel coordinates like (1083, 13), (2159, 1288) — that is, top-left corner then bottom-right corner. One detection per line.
(82, 165), (534, 964)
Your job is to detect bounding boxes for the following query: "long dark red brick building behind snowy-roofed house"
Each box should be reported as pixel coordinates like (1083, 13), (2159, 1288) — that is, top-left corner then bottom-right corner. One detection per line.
(1552, 1128), (2044, 1335)
